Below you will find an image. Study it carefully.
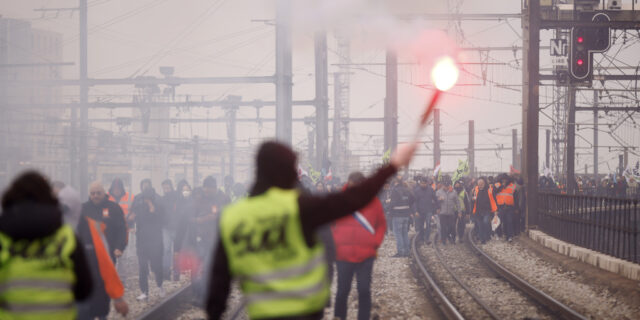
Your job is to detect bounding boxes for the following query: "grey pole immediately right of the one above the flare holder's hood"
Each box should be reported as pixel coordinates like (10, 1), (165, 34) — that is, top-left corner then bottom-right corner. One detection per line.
(314, 31), (336, 172)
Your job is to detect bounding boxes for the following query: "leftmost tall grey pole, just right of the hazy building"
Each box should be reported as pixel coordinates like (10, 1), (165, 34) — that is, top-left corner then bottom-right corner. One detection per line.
(79, 0), (89, 199)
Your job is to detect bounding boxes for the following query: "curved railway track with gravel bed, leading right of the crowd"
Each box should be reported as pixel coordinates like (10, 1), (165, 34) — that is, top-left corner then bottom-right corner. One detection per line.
(411, 232), (586, 319)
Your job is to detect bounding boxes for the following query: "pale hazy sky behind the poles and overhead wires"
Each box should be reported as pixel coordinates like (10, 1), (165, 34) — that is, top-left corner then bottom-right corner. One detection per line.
(0, 0), (640, 178)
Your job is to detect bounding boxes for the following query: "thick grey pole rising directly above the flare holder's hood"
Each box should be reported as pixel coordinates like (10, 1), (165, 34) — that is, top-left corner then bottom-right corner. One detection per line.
(276, 0), (293, 145)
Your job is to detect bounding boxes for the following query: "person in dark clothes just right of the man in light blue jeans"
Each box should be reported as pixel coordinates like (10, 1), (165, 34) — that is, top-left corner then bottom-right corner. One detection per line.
(413, 177), (438, 244)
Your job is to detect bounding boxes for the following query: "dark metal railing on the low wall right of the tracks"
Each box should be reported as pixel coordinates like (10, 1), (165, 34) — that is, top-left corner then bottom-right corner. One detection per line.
(535, 192), (640, 263)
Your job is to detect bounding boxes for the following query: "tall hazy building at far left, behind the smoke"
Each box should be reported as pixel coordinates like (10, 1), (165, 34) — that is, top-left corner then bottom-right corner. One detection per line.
(0, 18), (69, 188)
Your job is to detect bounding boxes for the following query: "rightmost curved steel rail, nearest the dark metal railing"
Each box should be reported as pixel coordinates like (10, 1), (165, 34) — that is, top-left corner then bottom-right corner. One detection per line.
(467, 233), (587, 320)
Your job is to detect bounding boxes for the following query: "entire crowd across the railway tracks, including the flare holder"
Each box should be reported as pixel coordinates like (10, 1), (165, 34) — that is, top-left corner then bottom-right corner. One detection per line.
(10, 138), (633, 319)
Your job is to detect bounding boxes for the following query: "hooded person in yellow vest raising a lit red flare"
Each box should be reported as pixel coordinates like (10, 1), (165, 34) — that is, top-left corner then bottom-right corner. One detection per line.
(206, 142), (416, 319)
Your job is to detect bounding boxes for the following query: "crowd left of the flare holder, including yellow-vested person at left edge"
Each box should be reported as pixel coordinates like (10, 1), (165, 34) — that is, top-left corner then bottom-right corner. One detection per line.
(0, 166), (245, 320)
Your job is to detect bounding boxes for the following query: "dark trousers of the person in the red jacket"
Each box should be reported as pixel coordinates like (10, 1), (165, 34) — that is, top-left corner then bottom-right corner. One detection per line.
(333, 258), (374, 320)
